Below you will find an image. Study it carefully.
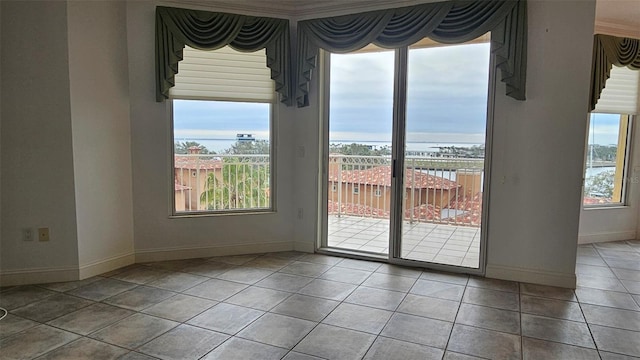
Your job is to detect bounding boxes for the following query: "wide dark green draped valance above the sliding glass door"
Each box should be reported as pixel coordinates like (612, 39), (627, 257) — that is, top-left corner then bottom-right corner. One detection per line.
(296, 0), (527, 107)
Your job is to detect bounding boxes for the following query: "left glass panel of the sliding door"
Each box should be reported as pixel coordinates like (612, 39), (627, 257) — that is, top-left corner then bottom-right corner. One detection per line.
(323, 45), (394, 255)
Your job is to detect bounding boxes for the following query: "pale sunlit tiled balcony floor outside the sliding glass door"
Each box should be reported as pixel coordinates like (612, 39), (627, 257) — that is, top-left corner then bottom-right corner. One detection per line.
(327, 215), (480, 268)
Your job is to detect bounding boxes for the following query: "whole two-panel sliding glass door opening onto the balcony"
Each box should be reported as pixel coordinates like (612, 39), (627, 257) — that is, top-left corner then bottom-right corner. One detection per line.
(322, 36), (490, 269)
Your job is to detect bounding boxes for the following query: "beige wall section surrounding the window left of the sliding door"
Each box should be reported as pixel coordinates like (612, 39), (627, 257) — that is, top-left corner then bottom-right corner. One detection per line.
(127, 1), (297, 261)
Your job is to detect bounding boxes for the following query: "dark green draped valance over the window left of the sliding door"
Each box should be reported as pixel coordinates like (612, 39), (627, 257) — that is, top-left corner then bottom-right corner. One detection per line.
(156, 6), (292, 105)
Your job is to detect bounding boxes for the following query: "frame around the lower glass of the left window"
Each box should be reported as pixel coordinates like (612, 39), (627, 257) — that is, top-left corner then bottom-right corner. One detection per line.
(165, 97), (280, 219)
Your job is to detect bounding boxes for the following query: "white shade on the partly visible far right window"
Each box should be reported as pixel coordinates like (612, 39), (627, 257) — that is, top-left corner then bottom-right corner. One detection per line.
(593, 66), (640, 115)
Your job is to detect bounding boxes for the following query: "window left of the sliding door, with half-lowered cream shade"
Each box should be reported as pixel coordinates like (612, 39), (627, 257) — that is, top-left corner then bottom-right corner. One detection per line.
(169, 47), (275, 214)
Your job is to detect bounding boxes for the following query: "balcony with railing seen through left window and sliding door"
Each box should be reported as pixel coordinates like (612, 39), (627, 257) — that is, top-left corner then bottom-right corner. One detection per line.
(174, 152), (484, 267)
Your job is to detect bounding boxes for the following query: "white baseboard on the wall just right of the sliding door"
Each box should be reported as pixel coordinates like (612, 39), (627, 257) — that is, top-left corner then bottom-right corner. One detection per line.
(485, 265), (576, 289)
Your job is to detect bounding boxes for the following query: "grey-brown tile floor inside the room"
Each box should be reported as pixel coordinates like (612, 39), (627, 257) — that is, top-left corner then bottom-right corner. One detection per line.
(0, 241), (640, 360)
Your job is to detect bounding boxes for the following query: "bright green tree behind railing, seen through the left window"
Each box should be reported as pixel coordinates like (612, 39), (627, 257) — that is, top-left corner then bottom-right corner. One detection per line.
(200, 157), (269, 210)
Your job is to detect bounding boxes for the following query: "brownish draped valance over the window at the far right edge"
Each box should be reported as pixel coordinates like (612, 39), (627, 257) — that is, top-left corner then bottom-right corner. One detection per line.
(589, 34), (640, 111)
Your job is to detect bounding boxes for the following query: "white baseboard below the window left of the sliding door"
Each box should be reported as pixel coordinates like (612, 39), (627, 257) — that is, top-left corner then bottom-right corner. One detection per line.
(136, 241), (294, 263)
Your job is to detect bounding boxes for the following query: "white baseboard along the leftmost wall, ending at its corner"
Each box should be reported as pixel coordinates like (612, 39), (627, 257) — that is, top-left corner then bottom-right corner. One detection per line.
(0, 267), (78, 286)
